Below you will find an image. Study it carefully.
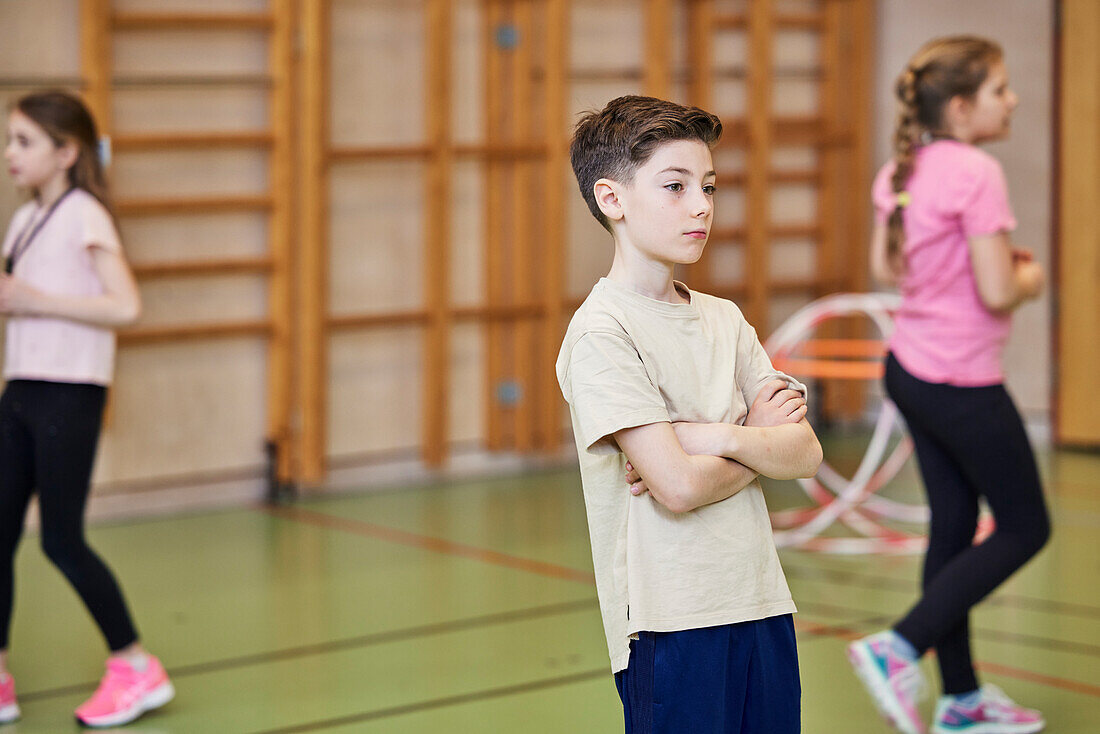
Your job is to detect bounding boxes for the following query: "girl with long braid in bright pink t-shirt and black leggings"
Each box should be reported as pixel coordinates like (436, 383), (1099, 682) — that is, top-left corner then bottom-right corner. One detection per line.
(848, 36), (1049, 734)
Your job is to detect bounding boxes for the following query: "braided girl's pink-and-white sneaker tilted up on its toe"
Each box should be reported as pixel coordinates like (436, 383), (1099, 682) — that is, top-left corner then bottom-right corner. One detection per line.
(848, 632), (925, 734)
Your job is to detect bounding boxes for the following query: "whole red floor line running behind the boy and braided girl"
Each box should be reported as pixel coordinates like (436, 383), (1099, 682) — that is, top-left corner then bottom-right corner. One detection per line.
(261, 505), (1100, 697)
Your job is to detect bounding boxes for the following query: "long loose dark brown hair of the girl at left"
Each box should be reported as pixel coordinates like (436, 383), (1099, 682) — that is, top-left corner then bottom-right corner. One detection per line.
(15, 91), (111, 211)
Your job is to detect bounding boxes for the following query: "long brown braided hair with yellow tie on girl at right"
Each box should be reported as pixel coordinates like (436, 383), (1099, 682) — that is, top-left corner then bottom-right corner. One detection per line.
(887, 35), (1003, 273)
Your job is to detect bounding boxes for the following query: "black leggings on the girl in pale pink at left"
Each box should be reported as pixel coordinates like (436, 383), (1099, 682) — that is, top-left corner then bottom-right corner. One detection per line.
(0, 380), (138, 651)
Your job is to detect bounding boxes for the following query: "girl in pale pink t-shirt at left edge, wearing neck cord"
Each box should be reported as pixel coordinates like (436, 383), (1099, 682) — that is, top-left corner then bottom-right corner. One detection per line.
(0, 92), (174, 726)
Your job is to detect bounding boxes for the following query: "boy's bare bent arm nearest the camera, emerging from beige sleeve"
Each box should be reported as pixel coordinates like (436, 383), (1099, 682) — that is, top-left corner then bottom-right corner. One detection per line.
(615, 423), (757, 513)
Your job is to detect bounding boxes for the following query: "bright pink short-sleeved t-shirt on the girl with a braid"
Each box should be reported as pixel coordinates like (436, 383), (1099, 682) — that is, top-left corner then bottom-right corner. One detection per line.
(872, 140), (1016, 387)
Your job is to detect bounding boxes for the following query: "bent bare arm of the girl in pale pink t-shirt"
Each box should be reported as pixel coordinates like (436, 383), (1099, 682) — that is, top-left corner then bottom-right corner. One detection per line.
(0, 248), (141, 328)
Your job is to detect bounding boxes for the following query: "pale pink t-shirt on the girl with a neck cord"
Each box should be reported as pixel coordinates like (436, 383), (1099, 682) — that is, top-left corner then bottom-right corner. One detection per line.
(3, 189), (122, 385)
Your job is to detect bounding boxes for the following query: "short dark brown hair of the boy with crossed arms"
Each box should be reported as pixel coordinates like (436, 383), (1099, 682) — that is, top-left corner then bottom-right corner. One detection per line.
(569, 95), (722, 232)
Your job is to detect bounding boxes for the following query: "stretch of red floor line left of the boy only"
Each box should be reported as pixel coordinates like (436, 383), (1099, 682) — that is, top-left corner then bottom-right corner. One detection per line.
(263, 505), (596, 585)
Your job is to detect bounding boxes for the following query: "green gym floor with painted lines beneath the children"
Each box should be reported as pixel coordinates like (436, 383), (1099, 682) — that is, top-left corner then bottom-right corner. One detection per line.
(0, 440), (1100, 734)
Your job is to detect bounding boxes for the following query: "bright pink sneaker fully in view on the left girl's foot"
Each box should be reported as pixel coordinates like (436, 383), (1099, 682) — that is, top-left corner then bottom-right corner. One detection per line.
(76, 655), (176, 726)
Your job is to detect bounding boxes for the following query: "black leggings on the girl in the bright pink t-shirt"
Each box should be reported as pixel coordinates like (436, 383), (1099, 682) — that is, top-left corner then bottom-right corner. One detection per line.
(886, 354), (1051, 694)
